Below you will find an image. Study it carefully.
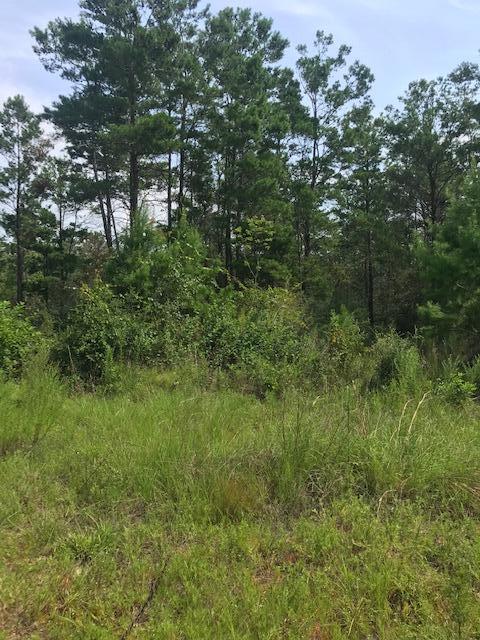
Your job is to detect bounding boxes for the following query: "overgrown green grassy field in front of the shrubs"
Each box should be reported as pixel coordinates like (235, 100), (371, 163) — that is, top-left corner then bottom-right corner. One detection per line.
(0, 364), (480, 640)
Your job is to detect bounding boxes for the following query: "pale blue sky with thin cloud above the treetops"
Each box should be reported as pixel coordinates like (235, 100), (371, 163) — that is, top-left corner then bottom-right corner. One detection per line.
(0, 0), (480, 110)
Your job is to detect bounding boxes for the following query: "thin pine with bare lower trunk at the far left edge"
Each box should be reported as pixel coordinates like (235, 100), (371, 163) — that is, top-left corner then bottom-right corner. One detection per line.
(0, 96), (48, 302)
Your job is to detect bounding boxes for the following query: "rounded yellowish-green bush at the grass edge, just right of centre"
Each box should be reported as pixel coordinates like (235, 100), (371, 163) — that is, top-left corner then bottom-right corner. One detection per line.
(202, 288), (313, 395)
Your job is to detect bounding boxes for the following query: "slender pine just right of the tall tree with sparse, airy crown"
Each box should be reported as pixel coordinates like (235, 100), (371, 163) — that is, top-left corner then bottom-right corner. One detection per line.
(336, 100), (417, 330)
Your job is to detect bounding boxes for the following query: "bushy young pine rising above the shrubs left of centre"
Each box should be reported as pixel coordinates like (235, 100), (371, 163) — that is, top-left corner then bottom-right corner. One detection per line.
(106, 212), (218, 366)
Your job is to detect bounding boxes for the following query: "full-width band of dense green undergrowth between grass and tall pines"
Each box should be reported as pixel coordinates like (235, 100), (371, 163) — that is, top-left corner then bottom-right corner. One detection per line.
(0, 214), (480, 404)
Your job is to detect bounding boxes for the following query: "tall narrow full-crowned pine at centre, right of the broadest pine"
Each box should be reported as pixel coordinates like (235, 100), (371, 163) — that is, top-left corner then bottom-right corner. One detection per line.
(201, 9), (287, 272)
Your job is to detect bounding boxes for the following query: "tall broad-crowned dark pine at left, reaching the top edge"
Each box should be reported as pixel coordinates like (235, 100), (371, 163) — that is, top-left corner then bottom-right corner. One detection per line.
(33, 0), (175, 229)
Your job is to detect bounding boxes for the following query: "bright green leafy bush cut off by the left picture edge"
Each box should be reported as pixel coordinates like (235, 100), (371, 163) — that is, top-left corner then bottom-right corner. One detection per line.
(0, 302), (45, 377)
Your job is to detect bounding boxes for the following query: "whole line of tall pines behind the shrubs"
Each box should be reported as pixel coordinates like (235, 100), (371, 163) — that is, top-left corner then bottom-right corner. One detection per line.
(0, 0), (480, 384)
